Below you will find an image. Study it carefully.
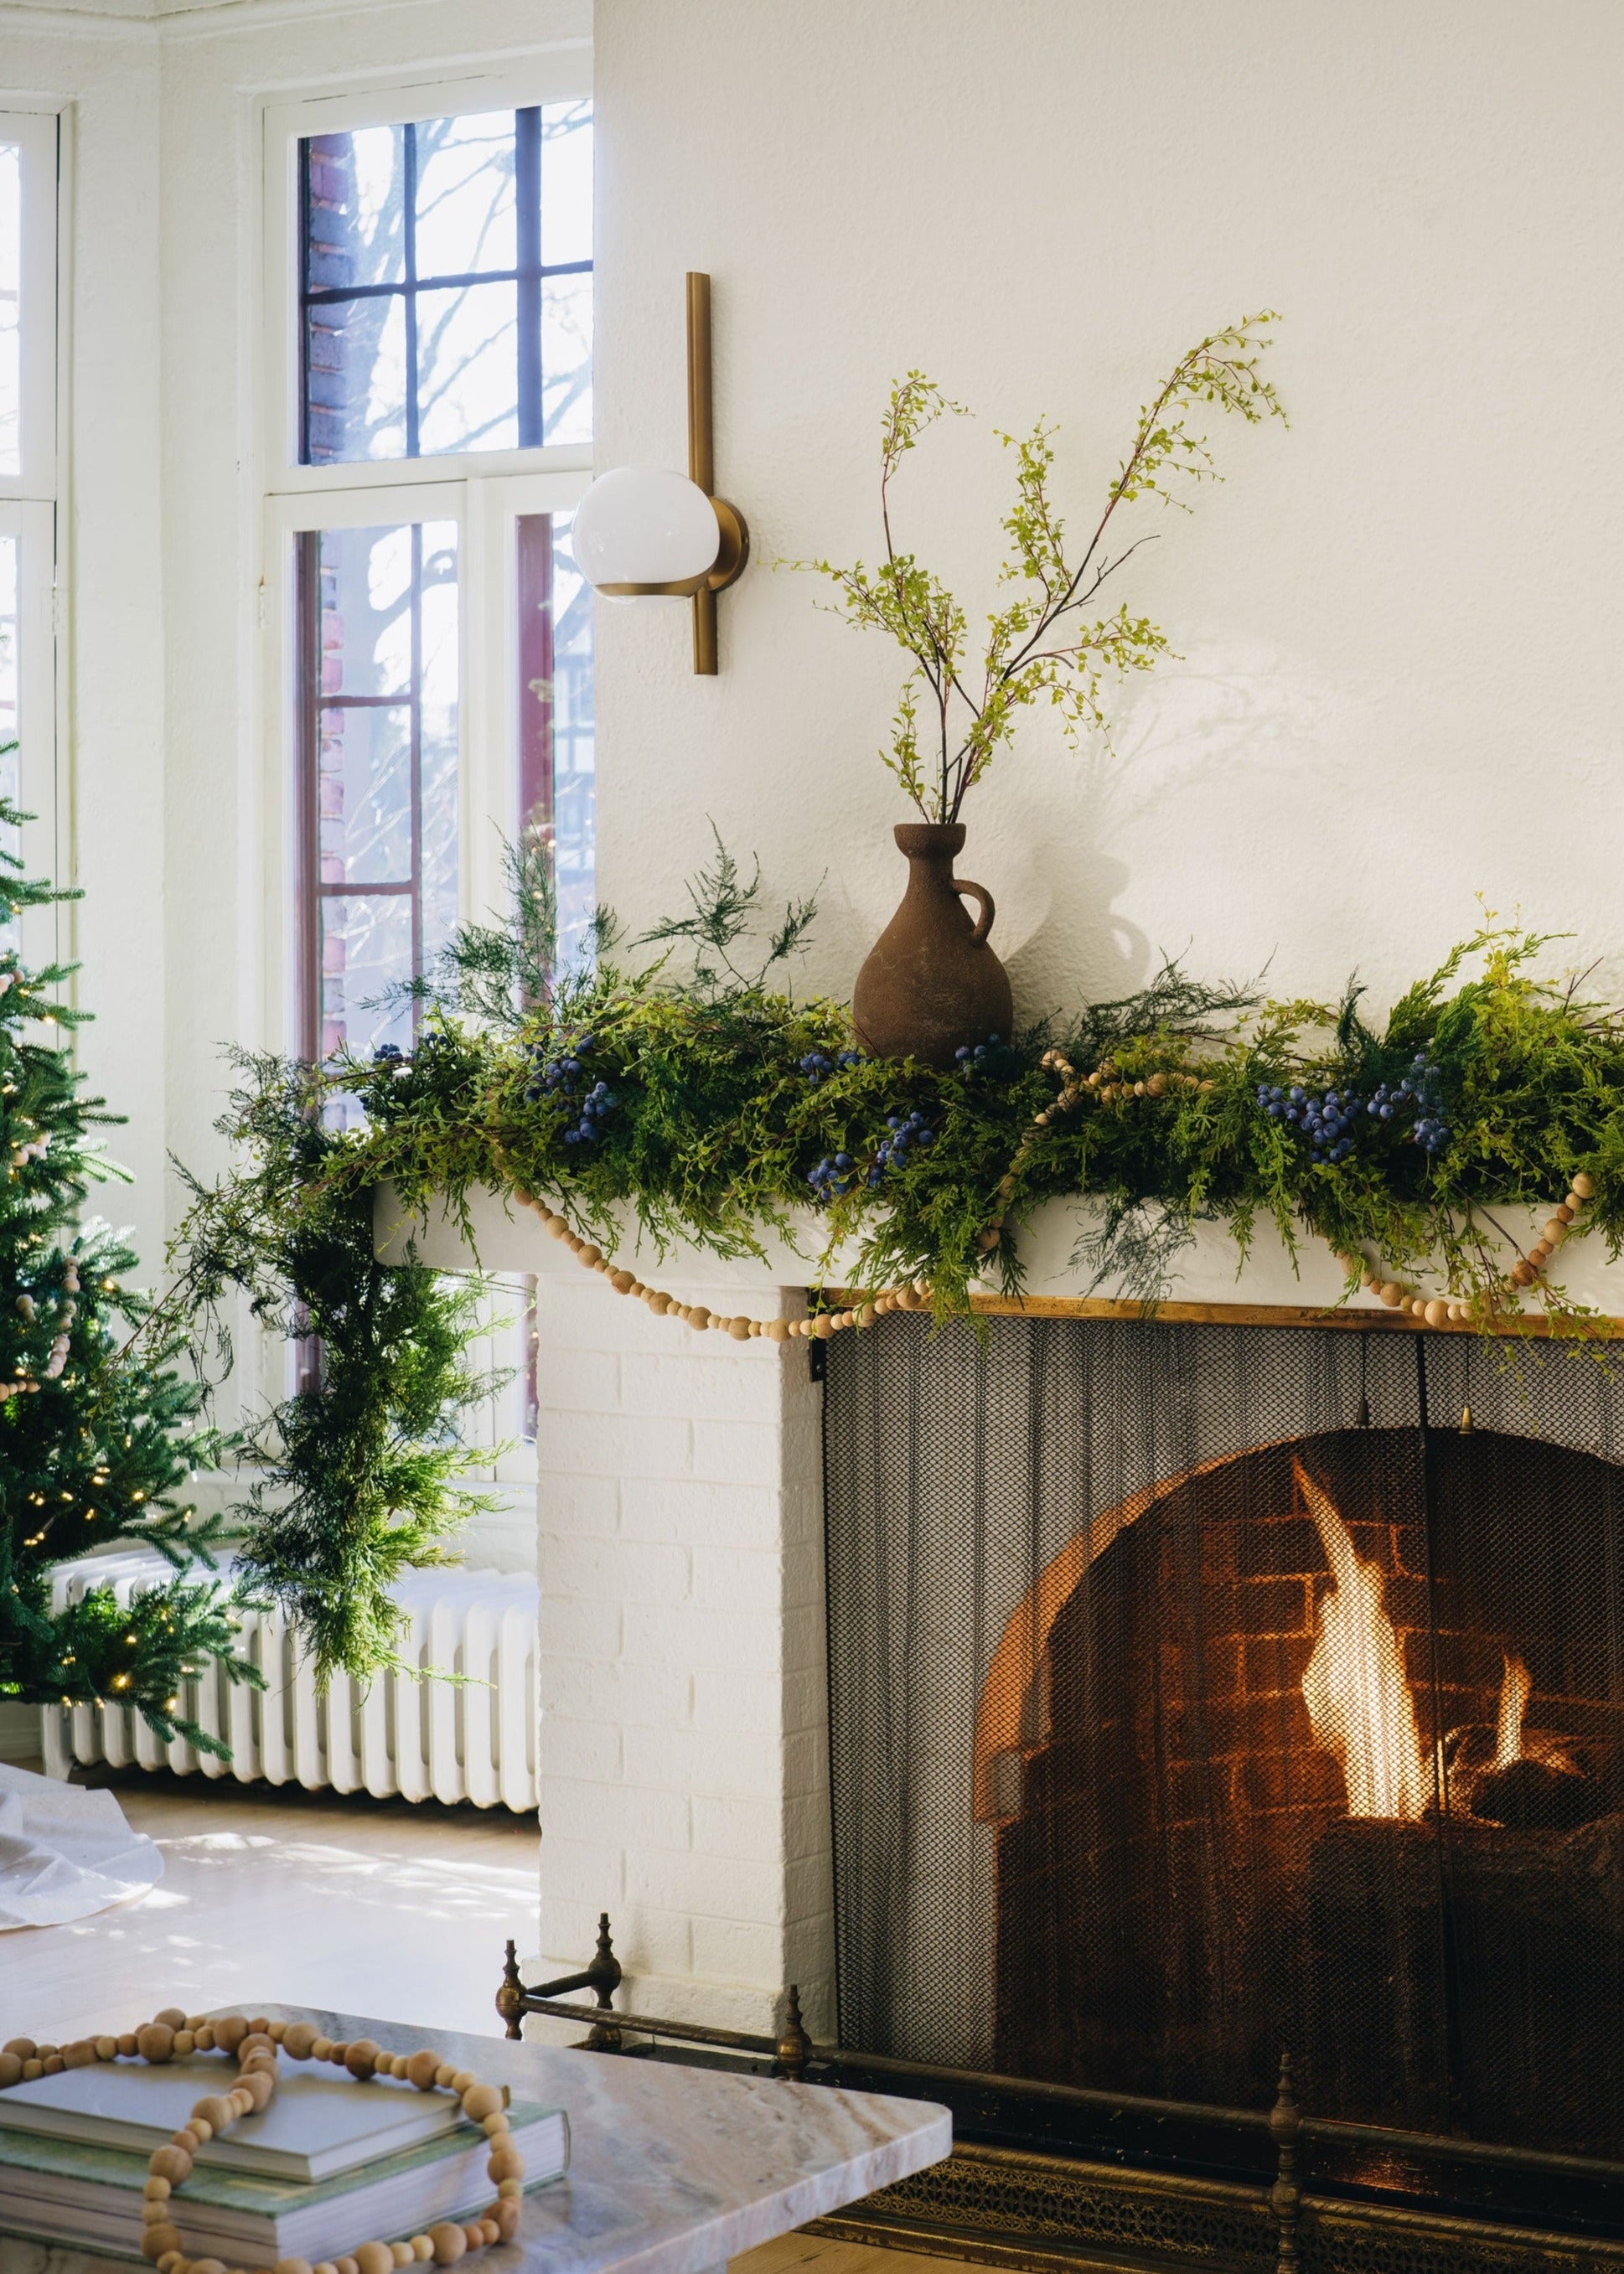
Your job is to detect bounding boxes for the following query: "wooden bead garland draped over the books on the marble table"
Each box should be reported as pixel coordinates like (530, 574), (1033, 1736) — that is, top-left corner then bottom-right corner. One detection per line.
(0, 2006), (525, 2274)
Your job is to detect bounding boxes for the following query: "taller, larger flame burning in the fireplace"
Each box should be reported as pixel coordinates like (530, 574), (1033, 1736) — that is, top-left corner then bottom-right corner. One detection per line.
(1292, 1462), (1428, 1824)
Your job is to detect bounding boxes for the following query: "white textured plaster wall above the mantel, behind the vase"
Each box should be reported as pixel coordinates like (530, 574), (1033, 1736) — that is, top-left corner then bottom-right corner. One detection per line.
(596, 0), (1624, 1012)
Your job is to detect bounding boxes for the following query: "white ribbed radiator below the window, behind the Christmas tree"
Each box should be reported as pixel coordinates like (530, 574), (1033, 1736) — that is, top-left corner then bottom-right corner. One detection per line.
(41, 1553), (539, 1812)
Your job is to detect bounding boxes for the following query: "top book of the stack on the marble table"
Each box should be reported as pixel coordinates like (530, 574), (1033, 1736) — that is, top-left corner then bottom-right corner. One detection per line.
(0, 2054), (462, 2183)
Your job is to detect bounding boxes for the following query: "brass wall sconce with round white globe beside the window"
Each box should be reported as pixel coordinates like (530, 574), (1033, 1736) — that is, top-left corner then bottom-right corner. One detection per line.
(573, 268), (751, 678)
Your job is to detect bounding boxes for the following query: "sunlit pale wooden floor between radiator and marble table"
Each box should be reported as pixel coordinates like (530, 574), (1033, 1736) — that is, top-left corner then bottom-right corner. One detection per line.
(0, 1765), (959, 2274)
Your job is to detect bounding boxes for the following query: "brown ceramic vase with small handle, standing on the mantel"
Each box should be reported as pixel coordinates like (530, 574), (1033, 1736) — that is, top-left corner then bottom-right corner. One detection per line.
(851, 821), (1015, 1067)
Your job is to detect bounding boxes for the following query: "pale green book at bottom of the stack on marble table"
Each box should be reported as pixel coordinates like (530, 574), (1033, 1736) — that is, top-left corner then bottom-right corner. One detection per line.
(0, 2071), (569, 2265)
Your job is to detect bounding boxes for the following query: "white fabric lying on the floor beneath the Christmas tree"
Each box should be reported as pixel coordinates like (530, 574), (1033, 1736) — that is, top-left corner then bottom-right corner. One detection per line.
(0, 1760), (163, 1930)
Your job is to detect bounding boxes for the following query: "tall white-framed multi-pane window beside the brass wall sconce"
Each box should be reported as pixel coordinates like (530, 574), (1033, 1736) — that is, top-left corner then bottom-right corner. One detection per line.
(264, 75), (596, 1481)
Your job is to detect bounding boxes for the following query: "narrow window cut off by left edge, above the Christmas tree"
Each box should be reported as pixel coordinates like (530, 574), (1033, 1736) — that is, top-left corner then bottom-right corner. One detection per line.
(0, 111), (66, 962)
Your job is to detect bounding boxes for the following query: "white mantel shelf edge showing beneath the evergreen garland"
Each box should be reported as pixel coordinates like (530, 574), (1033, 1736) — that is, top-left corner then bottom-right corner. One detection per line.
(373, 1185), (1624, 1332)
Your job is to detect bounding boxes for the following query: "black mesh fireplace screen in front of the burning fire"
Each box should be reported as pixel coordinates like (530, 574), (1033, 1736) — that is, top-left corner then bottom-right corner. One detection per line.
(825, 1319), (1624, 2158)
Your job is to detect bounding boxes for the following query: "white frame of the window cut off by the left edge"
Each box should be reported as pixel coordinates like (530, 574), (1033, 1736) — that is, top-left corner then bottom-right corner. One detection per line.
(0, 96), (73, 964)
